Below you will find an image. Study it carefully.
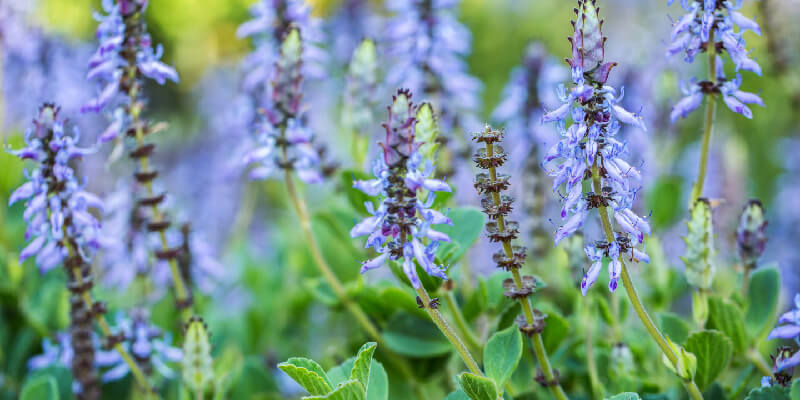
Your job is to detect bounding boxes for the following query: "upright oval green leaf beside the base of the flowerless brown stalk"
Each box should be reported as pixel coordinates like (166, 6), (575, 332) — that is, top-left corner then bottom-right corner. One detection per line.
(483, 325), (522, 388)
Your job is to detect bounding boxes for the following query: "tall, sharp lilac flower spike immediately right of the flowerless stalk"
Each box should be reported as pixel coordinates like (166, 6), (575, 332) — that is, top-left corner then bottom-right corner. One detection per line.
(542, 1), (650, 295)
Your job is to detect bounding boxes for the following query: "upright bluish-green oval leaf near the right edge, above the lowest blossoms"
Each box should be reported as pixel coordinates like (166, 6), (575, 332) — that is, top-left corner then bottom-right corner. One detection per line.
(745, 267), (781, 338)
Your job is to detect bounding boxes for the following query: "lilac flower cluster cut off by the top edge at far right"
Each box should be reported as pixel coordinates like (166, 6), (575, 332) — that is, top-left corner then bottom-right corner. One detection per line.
(667, 0), (764, 122)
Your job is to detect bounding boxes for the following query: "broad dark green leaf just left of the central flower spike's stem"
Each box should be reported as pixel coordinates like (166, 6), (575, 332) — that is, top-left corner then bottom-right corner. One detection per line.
(383, 313), (451, 357)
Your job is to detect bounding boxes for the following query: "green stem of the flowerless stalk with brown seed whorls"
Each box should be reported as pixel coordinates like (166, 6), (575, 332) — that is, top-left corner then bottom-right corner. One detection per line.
(486, 142), (568, 400)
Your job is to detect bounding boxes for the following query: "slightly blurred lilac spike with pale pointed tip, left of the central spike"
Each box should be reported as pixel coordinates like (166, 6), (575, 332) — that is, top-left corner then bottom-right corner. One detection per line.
(243, 29), (323, 183)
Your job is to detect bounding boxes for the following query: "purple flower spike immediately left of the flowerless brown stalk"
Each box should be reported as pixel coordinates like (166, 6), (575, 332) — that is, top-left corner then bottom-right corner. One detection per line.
(350, 90), (451, 288)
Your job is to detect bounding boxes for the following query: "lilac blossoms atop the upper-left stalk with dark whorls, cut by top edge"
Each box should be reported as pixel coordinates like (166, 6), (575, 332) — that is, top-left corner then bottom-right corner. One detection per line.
(82, 0), (179, 133)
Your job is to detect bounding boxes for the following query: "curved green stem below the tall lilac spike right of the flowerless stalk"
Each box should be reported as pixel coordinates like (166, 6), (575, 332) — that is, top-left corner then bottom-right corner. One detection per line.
(592, 166), (703, 400)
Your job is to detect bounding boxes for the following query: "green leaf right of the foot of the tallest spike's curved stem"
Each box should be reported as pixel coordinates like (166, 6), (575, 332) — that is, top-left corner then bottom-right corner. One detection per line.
(686, 331), (733, 389)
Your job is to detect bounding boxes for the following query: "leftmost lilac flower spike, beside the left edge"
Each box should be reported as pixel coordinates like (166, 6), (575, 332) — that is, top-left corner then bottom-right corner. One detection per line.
(8, 104), (103, 272)
